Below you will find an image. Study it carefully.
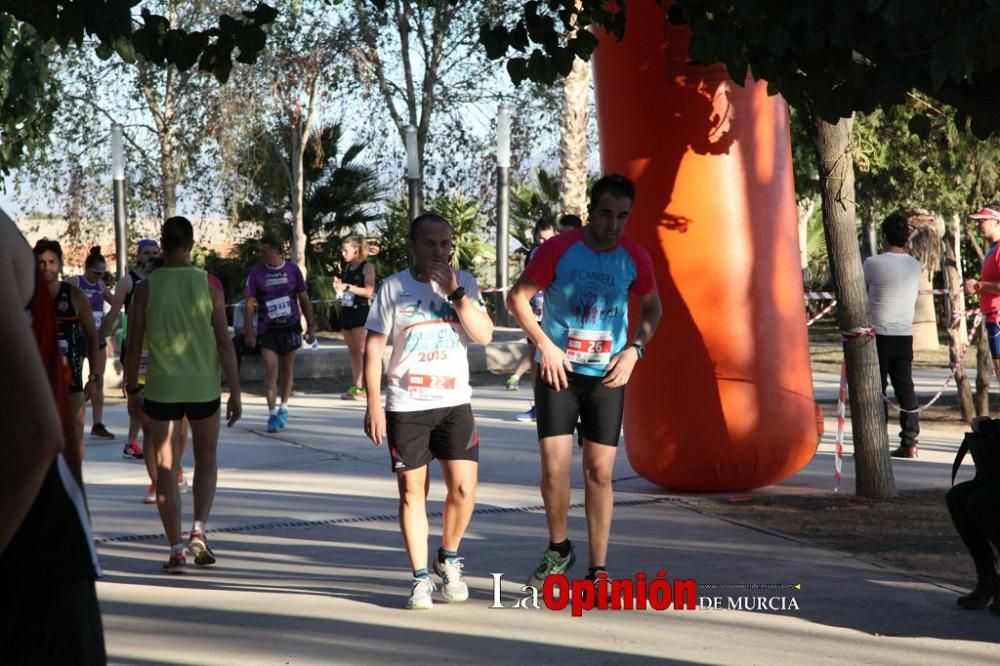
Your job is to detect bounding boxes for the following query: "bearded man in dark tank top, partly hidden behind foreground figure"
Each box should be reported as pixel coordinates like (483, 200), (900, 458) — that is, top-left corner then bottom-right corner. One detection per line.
(34, 238), (102, 488)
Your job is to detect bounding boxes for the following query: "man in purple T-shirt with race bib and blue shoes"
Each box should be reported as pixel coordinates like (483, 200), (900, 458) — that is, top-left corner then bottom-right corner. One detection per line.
(243, 235), (316, 432)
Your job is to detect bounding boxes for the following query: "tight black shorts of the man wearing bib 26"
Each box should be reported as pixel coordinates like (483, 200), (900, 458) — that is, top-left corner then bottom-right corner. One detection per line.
(535, 372), (625, 446)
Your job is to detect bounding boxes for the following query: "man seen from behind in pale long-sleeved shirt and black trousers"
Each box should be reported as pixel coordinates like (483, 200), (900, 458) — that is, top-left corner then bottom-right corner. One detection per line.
(864, 213), (922, 458)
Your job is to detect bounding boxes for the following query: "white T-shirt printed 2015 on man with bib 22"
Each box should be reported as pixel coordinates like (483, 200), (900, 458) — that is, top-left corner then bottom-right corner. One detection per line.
(365, 270), (483, 412)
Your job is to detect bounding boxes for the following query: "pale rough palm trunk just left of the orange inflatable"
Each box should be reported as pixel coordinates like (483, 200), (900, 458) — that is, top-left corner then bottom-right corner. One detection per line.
(559, 58), (590, 220)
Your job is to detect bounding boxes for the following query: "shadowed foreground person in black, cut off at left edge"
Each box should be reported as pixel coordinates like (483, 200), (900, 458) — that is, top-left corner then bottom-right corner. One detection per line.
(0, 219), (107, 664)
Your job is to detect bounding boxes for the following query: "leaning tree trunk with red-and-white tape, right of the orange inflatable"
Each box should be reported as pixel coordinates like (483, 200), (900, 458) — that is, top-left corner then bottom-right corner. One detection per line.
(809, 118), (896, 499)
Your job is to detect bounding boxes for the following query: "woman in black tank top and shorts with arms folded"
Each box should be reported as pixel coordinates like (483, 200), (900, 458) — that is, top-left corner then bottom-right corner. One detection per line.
(333, 236), (375, 401)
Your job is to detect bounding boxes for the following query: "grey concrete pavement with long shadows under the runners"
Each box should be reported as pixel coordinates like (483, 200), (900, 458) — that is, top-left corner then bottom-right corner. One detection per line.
(85, 378), (1000, 665)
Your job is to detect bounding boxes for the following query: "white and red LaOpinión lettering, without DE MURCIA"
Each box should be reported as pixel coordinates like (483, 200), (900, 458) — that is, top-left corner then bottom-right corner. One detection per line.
(490, 571), (698, 617)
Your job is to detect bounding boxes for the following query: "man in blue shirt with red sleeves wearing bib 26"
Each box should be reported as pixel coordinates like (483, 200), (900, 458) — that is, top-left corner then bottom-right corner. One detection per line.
(507, 175), (662, 588)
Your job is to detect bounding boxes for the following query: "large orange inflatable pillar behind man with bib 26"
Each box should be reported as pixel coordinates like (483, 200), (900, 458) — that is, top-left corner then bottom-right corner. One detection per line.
(594, 2), (817, 492)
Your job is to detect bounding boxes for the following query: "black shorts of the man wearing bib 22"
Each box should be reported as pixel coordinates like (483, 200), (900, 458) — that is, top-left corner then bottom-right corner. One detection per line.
(385, 404), (479, 472)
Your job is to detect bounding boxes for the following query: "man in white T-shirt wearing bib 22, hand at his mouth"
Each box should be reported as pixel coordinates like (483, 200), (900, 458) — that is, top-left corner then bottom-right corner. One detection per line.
(365, 213), (493, 609)
